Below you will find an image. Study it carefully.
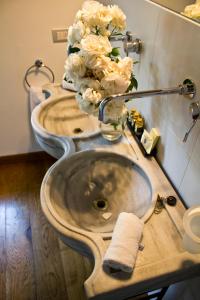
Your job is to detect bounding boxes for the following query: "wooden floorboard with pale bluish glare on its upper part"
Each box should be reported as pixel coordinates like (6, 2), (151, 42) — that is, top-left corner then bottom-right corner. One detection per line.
(6, 194), (36, 300)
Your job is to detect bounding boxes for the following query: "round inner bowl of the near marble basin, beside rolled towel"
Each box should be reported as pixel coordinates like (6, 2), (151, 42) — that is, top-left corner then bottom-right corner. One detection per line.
(41, 150), (154, 237)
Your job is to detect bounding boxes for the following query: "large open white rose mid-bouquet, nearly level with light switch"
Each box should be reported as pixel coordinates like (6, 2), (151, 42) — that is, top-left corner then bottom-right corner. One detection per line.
(81, 34), (112, 55)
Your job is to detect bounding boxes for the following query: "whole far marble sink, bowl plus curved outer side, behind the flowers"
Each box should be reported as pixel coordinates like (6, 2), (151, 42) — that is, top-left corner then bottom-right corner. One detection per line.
(31, 89), (100, 158)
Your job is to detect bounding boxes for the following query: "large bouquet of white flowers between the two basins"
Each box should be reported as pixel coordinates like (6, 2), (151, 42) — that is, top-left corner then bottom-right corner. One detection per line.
(65, 0), (137, 113)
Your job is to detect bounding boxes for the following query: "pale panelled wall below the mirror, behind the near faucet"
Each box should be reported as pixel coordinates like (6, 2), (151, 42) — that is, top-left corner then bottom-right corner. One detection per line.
(104, 0), (200, 210)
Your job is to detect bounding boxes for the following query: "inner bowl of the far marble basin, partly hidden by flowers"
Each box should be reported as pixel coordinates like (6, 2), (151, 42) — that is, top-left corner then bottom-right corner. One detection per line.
(31, 93), (100, 139)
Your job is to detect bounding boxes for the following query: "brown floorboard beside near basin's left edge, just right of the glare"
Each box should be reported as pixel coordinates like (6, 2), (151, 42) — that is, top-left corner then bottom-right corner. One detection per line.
(29, 190), (68, 300)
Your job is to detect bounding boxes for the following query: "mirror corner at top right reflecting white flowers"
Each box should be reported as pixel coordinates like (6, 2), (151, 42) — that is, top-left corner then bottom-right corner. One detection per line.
(152, 0), (200, 22)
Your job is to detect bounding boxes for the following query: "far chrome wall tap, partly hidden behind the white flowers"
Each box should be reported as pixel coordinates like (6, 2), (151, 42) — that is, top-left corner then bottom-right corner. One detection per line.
(109, 31), (142, 56)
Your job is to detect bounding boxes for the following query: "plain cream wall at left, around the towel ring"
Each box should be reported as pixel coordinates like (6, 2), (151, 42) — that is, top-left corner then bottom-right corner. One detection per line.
(0, 0), (83, 156)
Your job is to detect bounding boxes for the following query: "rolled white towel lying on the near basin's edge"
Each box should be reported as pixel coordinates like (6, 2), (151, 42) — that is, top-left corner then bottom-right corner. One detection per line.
(103, 212), (144, 273)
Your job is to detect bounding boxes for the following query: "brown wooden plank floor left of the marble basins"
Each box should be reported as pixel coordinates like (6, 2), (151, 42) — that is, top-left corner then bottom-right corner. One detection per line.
(0, 155), (93, 300)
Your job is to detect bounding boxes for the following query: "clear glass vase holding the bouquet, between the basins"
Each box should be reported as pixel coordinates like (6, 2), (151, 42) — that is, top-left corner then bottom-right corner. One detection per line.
(99, 101), (127, 141)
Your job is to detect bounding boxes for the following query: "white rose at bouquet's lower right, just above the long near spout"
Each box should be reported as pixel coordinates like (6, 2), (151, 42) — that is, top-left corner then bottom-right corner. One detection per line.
(101, 73), (130, 95)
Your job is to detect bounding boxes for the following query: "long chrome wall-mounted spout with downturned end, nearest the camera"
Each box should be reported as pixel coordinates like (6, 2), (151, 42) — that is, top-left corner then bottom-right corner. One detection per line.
(99, 79), (196, 123)
